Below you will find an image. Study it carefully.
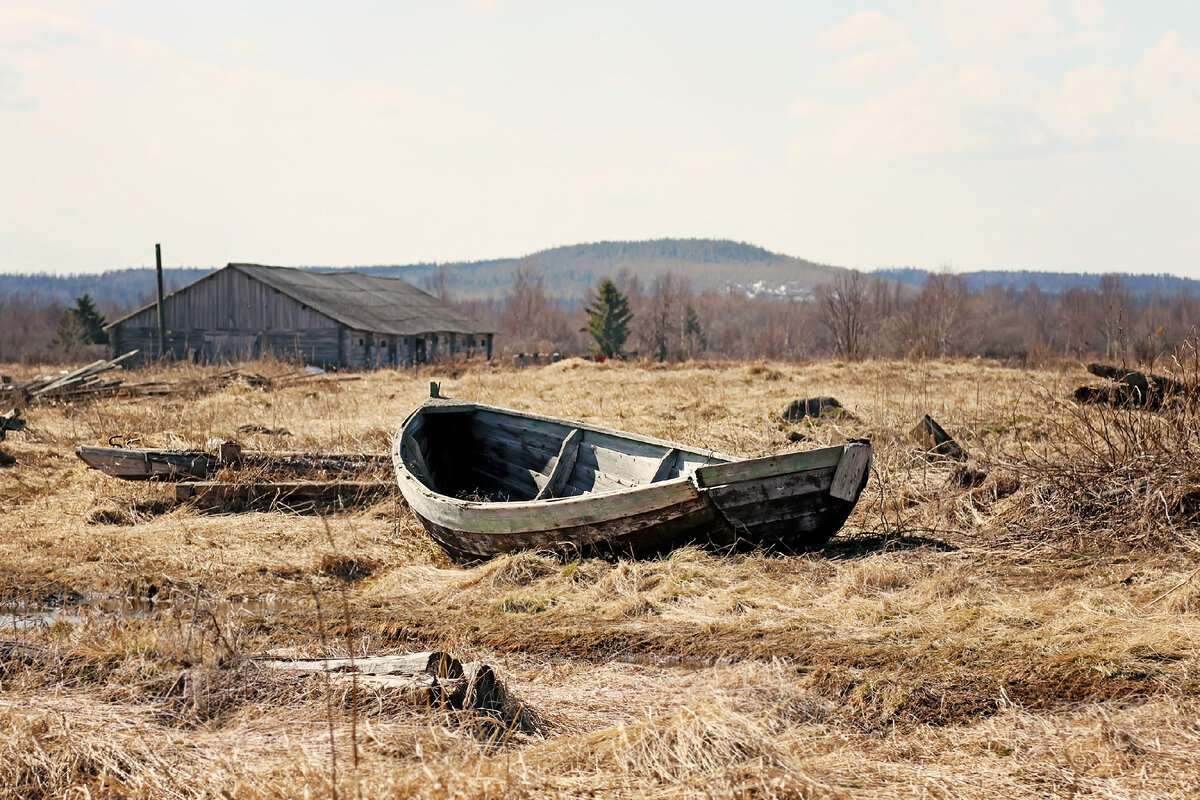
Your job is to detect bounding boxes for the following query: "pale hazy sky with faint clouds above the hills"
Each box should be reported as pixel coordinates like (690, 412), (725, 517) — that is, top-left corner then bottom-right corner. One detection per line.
(0, 0), (1200, 277)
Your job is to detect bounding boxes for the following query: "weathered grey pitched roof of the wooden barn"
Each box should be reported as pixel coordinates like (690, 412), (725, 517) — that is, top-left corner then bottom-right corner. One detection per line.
(106, 264), (496, 336)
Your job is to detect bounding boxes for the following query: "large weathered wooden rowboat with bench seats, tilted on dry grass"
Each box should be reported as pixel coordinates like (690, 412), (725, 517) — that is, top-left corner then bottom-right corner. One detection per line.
(392, 398), (871, 560)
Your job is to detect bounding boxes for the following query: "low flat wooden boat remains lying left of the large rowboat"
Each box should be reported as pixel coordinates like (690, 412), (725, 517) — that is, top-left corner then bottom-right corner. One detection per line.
(76, 443), (390, 482)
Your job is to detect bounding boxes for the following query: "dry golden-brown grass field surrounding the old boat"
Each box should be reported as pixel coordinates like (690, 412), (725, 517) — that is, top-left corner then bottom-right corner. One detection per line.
(0, 360), (1200, 799)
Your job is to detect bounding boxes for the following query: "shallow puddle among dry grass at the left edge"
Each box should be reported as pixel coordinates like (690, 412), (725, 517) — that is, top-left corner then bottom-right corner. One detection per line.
(0, 597), (292, 628)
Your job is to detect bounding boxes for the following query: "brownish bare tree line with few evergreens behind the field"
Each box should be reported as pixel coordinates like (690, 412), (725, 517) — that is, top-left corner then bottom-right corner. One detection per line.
(0, 268), (1200, 362)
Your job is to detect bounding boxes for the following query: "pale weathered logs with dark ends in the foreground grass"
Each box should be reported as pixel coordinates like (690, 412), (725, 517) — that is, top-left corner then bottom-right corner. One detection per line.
(258, 650), (505, 711)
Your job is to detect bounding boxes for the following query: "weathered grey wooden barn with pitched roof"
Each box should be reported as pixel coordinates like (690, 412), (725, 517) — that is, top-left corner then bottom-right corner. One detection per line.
(106, 264), (493, 368)
